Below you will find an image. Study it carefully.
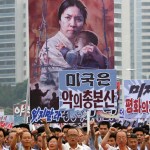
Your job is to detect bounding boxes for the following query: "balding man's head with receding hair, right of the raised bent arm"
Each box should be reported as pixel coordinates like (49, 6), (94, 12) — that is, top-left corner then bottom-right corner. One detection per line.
(116, 131), (127, 147)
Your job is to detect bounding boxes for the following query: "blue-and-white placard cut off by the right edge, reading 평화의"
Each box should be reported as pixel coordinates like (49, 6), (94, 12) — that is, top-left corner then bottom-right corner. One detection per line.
(124, 80), (150, 119)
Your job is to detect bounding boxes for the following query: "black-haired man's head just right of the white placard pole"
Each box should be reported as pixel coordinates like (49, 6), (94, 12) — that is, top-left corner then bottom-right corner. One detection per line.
(98, 121), (110, 138)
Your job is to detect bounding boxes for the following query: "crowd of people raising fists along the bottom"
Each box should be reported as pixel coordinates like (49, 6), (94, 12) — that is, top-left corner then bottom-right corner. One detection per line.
(0, 118), (150, 150)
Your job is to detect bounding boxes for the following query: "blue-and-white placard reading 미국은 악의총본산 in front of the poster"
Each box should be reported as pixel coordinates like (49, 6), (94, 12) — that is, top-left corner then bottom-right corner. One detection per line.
(59, 69), (118, 111)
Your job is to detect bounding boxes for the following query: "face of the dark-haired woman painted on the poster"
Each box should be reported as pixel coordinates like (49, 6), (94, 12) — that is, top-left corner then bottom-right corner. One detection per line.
(59, 6), (84, 40)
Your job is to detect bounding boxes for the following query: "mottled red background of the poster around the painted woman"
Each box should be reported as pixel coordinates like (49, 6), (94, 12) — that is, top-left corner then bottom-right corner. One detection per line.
(29, 0), (114, 82)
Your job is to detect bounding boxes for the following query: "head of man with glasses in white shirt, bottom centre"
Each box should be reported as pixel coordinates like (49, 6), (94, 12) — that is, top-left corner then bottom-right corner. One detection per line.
(66, 127), (79, 145)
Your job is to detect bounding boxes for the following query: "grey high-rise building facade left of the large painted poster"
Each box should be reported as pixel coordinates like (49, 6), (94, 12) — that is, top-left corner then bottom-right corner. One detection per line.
(0, 0), (29, 85)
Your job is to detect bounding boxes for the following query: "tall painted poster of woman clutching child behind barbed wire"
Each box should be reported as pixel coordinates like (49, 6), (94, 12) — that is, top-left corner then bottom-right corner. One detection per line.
(29, 0), (115, 122)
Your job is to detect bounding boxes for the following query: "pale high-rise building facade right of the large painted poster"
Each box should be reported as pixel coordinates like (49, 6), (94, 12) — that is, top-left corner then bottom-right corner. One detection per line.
(114, 0), (150, 79)
